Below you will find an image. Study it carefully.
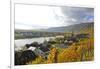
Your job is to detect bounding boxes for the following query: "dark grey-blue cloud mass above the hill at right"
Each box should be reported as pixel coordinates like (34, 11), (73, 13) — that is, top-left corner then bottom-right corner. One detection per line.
(61, 7), (94, 24)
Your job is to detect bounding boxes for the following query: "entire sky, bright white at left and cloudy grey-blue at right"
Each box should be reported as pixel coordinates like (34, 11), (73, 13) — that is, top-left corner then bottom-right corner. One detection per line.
(15, 4), (94, 29)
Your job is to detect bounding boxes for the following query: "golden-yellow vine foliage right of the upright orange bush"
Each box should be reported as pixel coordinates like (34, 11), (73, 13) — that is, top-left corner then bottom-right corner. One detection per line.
(58, 39), (94, 63)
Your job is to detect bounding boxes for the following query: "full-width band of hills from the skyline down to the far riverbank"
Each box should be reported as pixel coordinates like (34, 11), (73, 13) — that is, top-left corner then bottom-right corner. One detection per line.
(15, 22), (94, 39)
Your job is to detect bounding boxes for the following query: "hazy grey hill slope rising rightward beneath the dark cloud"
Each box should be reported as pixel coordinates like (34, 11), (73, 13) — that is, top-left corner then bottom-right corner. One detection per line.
(45, 22), (94, 32)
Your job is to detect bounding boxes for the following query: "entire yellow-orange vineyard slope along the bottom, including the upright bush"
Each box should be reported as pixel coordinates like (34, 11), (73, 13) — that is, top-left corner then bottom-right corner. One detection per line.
(28, 31), (94, 64)
